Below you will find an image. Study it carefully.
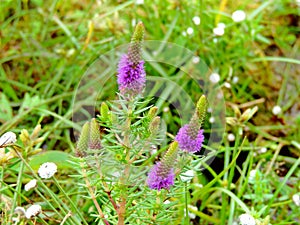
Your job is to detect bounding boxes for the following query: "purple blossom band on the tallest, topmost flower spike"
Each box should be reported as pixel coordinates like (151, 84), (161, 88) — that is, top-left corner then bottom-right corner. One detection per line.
(118, 54), (146, 95)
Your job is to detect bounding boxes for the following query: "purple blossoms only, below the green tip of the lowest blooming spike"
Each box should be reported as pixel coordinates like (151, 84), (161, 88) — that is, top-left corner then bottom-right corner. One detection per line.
(147, 162), (175, 190)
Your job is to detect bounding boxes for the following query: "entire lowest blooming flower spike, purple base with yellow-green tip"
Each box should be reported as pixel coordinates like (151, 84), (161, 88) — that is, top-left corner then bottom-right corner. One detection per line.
(147, 141), (178, 190)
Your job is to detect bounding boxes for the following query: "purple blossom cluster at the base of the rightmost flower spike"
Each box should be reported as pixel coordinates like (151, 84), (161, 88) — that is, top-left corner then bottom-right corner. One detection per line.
(175, 124), (204, 153)
